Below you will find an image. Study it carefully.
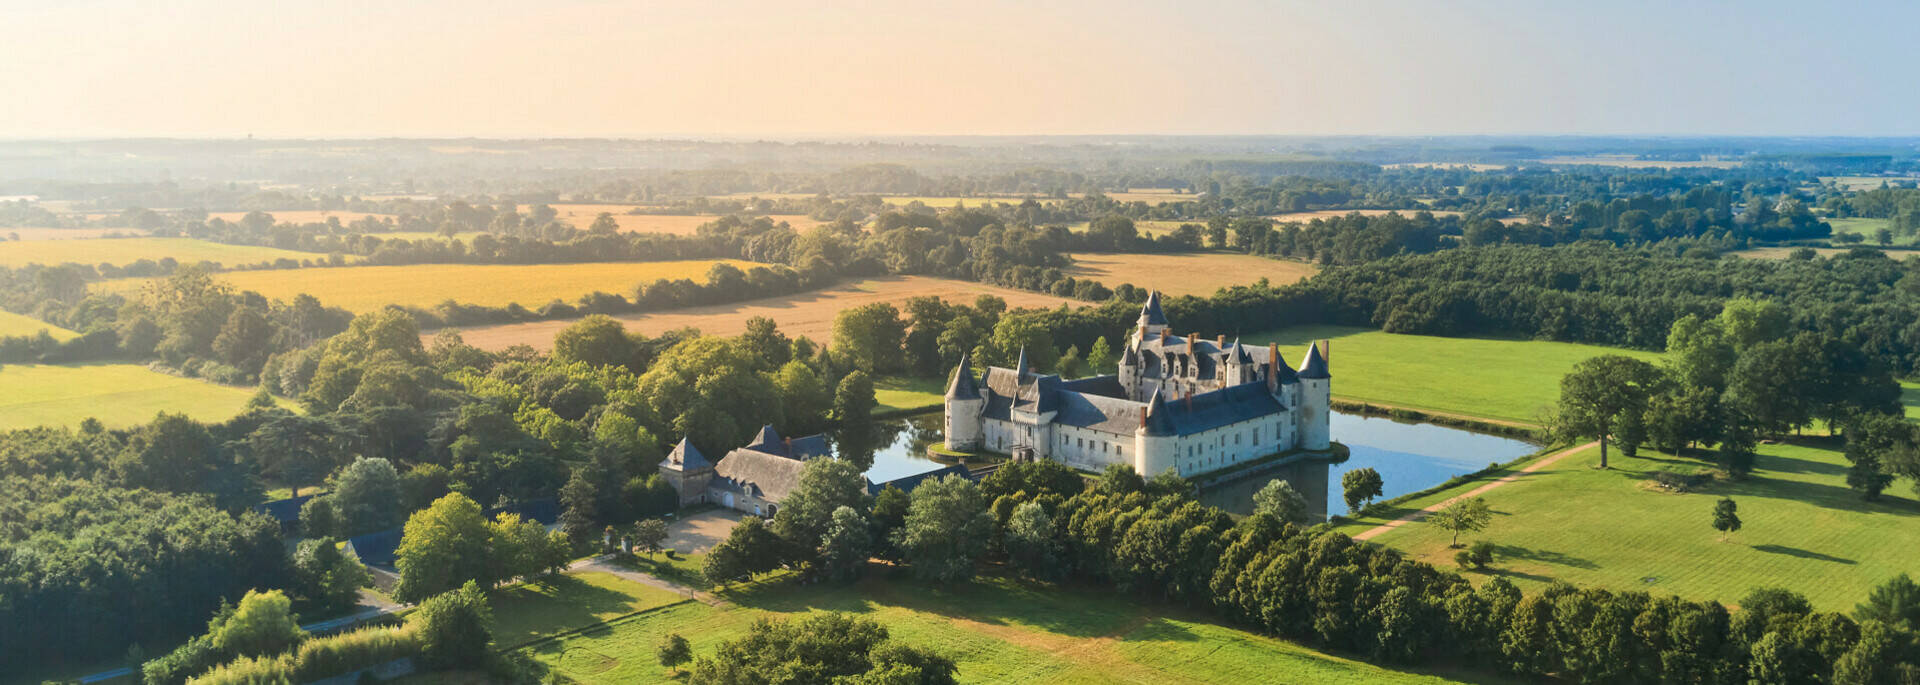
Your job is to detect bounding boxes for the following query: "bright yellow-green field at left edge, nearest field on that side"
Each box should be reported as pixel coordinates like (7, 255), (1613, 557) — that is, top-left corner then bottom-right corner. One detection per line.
(0, 365), (270, 430)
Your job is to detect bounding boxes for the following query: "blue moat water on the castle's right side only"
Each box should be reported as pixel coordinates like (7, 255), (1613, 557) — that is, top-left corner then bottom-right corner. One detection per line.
(1200, 413), (1540, 516)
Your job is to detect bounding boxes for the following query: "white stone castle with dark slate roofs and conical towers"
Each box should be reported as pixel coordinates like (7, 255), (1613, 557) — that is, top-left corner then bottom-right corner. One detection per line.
(947, 292), (1332, 476)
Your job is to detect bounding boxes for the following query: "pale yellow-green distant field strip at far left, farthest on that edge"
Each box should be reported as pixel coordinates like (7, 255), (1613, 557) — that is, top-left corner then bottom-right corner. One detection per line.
(0, 238), (326, 267)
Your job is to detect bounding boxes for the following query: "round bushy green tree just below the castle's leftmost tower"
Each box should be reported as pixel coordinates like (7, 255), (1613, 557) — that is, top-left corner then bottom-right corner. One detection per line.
(900, 476), (993, 583)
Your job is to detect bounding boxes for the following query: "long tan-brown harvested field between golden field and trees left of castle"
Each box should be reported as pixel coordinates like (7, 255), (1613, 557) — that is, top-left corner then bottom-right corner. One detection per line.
(437, 276), (1075, 349)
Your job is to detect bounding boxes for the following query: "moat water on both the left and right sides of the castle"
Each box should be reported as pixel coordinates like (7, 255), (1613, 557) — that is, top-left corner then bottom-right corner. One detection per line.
(848, 404), (1538, 518)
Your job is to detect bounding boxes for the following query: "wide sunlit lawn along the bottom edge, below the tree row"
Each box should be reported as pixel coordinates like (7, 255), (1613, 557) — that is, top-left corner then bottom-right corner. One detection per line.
(528, 578), (1489, 683)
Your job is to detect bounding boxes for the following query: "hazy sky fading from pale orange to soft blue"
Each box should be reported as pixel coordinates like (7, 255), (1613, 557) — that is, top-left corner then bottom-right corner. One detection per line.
(0, 0), (1920, 138)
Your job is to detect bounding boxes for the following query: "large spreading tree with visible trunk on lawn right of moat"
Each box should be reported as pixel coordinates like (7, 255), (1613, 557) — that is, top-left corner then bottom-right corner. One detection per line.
(1555, 355), (1661, 468)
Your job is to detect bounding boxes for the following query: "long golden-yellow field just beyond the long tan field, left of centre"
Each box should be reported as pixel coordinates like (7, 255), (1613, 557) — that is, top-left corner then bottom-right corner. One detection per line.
(94, 259), (758, 313)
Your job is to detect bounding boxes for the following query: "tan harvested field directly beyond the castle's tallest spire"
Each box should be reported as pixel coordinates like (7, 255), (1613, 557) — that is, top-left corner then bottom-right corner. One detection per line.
(1068, 251), (1319, 295)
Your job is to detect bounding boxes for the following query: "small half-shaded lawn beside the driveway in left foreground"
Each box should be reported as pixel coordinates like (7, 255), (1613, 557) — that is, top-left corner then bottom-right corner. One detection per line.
(488, 572), (685, 647)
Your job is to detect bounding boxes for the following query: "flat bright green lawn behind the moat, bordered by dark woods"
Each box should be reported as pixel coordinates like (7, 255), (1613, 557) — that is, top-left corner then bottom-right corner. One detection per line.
(1242, 326), (1661, 422)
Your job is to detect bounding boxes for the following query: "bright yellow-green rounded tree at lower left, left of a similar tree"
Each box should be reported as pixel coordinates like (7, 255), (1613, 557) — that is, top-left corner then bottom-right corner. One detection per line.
(394, 493), (492, 602)
